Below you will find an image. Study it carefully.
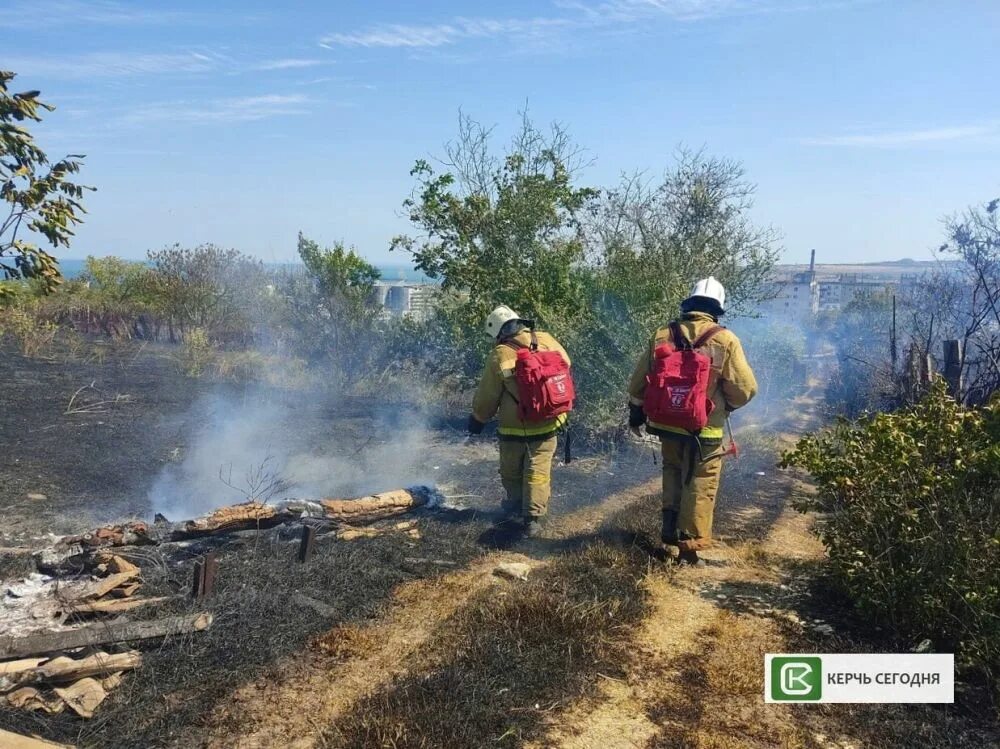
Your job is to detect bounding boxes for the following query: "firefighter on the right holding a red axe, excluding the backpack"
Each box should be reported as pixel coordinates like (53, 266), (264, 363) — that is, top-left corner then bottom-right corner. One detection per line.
(628, 276), (757, 564)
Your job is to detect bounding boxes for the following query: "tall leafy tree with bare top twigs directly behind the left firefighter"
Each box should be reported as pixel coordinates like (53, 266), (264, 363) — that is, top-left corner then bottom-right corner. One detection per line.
(392, 114), (597, 338)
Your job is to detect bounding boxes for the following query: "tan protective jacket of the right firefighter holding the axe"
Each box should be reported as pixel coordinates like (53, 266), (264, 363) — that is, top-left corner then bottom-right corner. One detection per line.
(628, 312), (757, 440)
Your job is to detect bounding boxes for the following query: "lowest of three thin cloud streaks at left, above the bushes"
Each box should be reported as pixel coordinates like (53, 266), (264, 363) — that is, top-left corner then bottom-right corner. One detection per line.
(122, 94), (312, 125)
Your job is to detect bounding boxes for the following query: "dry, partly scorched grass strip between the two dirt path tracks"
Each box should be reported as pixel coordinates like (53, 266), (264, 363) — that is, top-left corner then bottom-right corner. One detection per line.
(320, 545), (645, 749)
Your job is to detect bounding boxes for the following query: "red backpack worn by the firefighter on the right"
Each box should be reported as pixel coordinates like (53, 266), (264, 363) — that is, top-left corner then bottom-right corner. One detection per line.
(642, 321), (725, 434)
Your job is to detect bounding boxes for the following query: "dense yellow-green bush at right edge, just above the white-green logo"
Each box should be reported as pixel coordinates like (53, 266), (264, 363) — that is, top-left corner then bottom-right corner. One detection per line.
(782, 381), (1000, 697)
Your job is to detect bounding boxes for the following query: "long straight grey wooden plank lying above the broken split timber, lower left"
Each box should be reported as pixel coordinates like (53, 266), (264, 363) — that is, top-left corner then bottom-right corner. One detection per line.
(0, 612), (213, 658)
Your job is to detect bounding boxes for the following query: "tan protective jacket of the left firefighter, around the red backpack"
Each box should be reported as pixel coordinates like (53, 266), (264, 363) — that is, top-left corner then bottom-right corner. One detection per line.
(472, 330), (571, 440)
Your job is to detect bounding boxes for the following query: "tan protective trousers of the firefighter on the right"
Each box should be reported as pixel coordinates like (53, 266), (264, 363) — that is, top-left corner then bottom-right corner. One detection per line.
(660, 437), (722, 551)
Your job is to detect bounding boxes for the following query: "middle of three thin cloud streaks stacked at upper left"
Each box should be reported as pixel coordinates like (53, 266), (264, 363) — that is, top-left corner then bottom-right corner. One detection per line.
(6, 52), (226, 80)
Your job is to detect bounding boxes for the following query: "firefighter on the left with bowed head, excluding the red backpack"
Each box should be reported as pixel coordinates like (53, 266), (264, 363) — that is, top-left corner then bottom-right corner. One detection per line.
(468, 306), (570, 536)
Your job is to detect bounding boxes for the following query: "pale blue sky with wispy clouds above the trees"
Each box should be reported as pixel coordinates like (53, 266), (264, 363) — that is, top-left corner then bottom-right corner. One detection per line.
(7, 0), (1000, 264)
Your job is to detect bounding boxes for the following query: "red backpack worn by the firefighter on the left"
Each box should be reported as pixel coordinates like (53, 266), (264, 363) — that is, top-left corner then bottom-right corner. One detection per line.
(503, 331), (576, 422)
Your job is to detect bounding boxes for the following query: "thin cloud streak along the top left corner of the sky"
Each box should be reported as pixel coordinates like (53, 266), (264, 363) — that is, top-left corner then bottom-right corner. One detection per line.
(0, 0), (190, 29)
